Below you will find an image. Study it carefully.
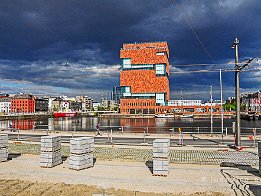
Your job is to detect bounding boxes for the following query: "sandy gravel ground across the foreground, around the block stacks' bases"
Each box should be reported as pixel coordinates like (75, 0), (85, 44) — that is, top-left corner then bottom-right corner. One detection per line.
(0, 155), (233, 195)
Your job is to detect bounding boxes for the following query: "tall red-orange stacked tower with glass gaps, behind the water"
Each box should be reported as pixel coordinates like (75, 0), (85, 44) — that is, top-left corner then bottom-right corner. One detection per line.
(120, 42), (170, 114)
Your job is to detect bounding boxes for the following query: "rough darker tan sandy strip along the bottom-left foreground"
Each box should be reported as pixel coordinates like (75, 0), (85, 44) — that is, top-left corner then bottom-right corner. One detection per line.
(0, 180), (174, 196)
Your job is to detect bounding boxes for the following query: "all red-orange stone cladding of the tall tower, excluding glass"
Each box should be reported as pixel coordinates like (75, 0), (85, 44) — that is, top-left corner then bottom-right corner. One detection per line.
(120, 42), (169, 114)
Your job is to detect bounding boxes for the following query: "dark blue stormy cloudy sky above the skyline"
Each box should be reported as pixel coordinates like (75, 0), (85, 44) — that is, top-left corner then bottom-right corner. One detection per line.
(0, 0), (261, 99)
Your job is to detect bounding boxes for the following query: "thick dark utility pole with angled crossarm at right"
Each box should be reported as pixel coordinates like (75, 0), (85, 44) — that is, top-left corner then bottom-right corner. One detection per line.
(231, 37), (254, 146)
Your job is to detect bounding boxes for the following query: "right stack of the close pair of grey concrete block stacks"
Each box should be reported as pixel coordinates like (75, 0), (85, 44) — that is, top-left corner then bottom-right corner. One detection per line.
(69, 137), (94, 170)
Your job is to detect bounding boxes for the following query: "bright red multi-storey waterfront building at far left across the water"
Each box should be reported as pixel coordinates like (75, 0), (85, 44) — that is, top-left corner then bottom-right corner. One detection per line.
(11, 93), (35, 113)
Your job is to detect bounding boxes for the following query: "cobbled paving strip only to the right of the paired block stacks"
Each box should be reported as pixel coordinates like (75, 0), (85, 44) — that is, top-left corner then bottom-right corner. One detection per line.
(94, 147), (258, 166)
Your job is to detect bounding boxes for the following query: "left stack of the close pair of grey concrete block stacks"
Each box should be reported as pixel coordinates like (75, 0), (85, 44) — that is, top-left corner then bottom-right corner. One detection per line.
(40, 136), (62, 167)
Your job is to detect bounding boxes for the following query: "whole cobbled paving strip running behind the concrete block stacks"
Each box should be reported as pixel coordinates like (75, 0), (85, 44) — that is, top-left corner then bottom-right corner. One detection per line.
(9, 143), (259, 166)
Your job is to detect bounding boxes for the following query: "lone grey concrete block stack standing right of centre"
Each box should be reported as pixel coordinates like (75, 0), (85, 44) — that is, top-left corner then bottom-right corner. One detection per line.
(153, 139), (170, 176)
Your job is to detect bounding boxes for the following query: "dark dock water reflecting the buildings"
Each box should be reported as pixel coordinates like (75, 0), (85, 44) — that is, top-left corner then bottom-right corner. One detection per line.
(0, 117), (261, 133)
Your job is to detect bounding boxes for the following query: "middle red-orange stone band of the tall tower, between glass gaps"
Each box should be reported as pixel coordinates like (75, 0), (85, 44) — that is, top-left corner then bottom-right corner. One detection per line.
(120, 70), (169, 100)
